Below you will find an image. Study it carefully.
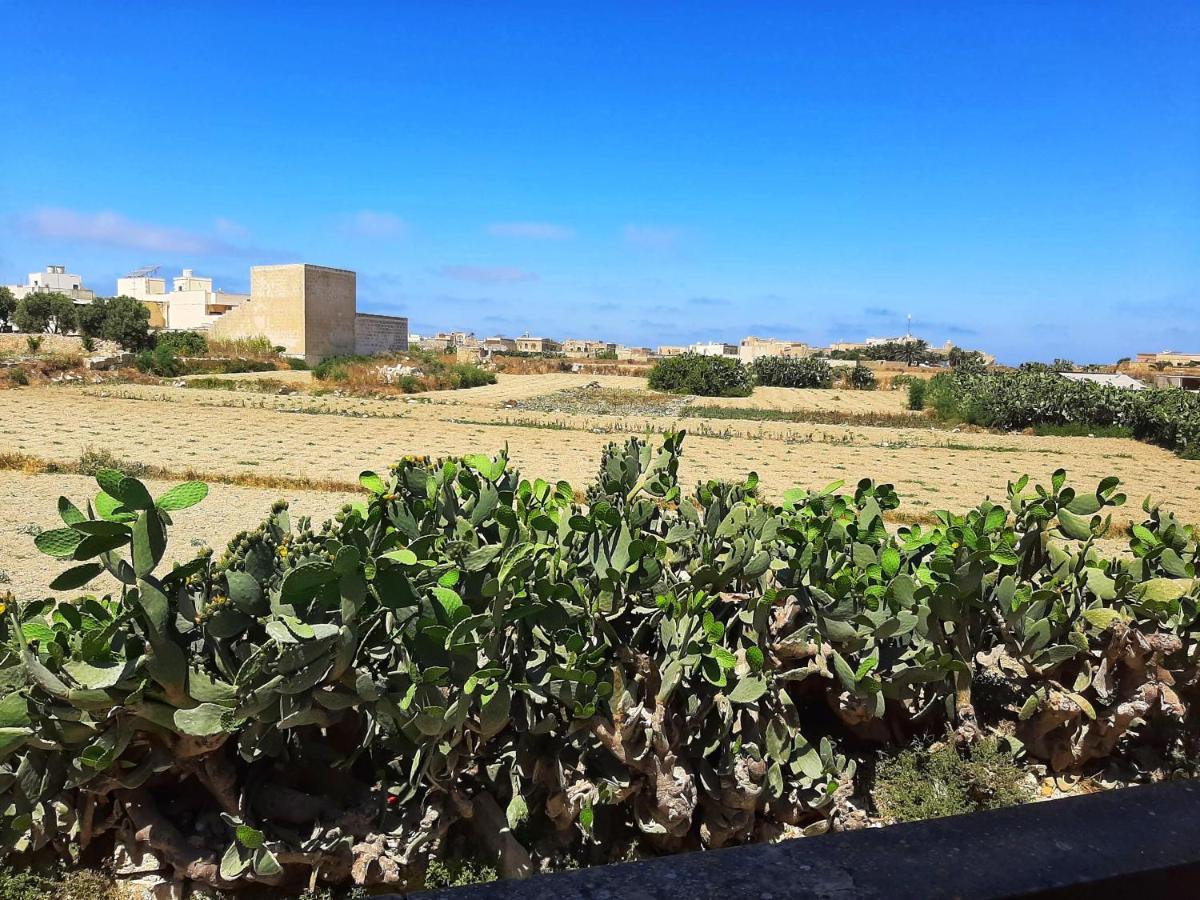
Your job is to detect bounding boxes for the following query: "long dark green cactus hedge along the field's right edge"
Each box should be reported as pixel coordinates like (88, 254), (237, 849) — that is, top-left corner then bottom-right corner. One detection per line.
(910, 370), (1200, 458)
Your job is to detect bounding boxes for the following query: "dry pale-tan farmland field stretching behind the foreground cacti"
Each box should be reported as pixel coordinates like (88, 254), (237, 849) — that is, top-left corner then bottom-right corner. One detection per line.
(0, 372), (1200, 595)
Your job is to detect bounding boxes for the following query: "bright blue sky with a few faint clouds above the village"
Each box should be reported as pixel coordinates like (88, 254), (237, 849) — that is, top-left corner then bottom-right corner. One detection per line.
(0, 0), (1200, 361)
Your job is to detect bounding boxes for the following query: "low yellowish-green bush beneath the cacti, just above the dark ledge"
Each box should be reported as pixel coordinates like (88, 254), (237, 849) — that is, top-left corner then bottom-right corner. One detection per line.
(871, 737), (1033, 822)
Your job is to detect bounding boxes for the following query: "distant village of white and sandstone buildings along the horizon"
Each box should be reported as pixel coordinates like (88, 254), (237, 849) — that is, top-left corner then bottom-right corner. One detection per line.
(0, 264), (1200, 388)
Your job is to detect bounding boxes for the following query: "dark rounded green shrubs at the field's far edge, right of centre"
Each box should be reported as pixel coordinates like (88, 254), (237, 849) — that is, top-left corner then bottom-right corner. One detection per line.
(649, 353), (876, 397)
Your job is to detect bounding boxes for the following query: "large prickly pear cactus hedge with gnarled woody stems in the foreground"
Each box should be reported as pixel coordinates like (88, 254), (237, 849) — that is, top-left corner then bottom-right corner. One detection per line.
(0, 434), (1200, 887)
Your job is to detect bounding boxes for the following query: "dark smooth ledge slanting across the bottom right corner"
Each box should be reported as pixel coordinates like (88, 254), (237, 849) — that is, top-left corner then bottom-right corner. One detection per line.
(405, 781), (1200, 900)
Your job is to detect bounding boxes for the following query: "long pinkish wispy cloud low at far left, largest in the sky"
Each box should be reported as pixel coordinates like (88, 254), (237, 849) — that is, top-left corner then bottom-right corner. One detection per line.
(7, 208), (259, 257)
